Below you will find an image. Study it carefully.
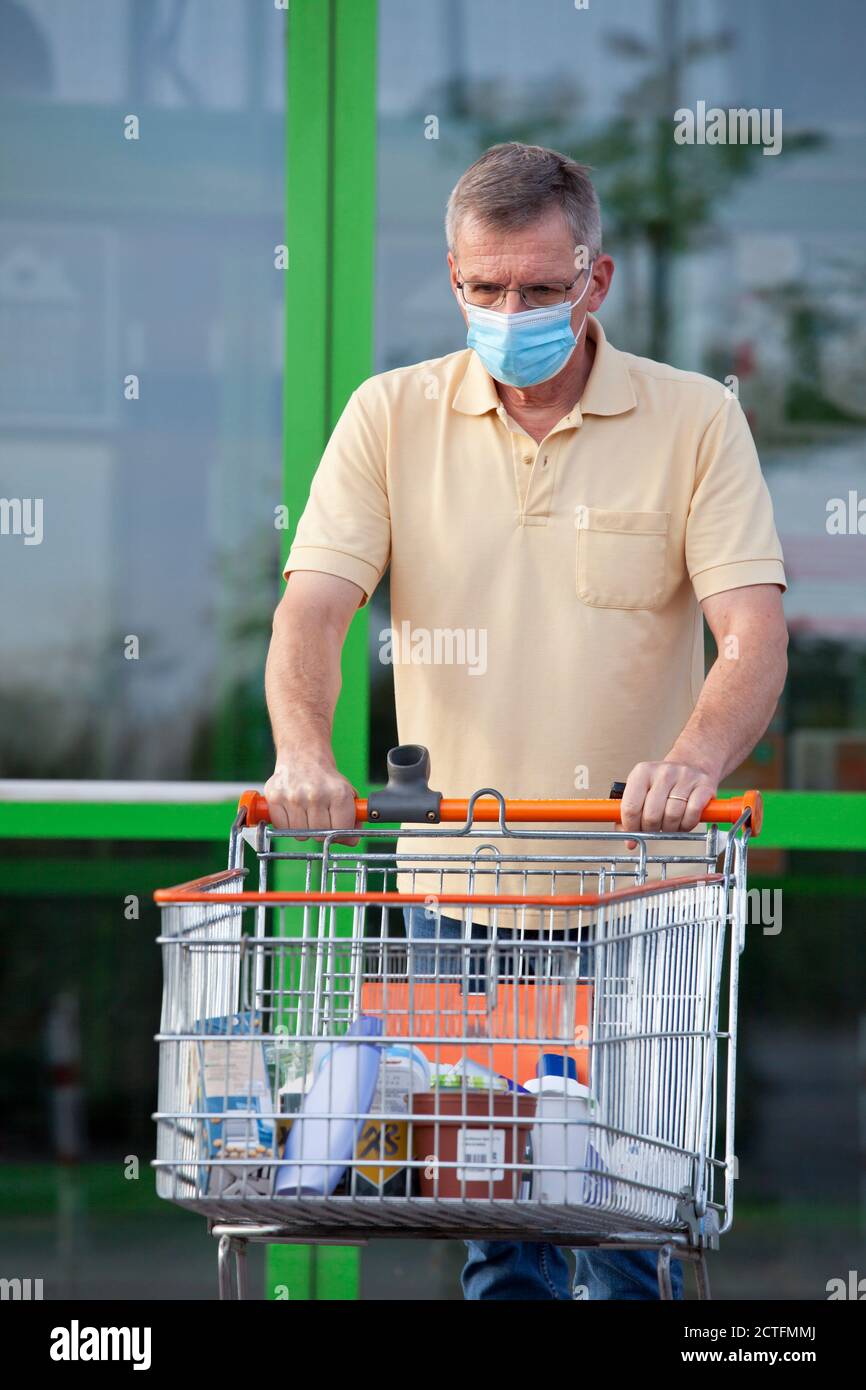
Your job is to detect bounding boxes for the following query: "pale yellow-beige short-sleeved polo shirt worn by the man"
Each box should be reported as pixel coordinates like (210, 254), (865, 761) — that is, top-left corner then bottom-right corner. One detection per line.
(285, 316), (785, 917)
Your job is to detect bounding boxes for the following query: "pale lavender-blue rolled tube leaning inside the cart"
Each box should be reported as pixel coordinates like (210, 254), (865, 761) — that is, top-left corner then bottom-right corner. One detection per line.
(274, 1015), (382, 1197)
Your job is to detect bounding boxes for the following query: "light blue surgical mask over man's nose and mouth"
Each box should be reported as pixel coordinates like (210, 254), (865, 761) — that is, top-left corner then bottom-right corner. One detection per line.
(466, 267), (592, 386)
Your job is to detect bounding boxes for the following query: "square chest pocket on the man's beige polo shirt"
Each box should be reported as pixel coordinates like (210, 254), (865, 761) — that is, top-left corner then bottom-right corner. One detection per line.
(575, 507), (670, 609)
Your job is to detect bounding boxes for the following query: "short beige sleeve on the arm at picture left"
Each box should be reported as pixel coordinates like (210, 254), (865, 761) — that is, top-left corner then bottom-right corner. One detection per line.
(282, 391), (391, 606)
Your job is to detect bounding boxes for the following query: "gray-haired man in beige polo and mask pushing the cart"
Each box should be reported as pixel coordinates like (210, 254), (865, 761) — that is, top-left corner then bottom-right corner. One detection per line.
(265, 143), (787, 1298)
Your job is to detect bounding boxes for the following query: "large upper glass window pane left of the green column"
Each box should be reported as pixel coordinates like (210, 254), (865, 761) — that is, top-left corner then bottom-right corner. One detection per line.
(0, 0), (285, 778)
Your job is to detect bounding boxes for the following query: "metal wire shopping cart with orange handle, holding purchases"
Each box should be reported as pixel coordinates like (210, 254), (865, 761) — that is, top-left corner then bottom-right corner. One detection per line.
(154, 745), (762, 1298)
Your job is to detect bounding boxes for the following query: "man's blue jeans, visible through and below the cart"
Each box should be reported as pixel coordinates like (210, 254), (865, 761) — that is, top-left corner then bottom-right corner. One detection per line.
(403, 908), (683, 1300)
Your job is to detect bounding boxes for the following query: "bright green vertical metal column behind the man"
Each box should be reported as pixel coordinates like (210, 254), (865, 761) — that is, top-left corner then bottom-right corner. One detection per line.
(265, 0), (377, 1300)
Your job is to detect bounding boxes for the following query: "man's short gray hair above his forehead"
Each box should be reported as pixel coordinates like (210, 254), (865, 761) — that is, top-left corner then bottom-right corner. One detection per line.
(445, 140), (602, 260)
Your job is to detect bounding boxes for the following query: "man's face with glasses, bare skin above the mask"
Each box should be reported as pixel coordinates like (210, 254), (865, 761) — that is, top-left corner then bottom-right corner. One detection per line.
(448, 211), (613, 332)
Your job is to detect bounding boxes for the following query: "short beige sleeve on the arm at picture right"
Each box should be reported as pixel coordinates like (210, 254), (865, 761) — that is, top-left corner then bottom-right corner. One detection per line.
(685, 396), (787, 602)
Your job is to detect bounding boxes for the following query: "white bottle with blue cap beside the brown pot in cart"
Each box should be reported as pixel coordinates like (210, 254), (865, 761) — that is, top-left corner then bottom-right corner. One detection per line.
(525, 1052), (596, 1207)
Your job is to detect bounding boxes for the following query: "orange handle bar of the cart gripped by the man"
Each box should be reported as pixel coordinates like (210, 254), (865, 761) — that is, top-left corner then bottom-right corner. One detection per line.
(238, 791), (763, 835)
